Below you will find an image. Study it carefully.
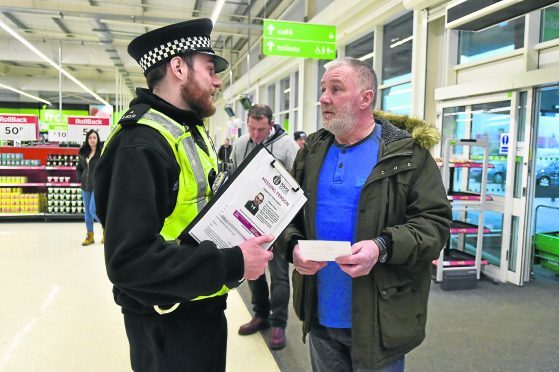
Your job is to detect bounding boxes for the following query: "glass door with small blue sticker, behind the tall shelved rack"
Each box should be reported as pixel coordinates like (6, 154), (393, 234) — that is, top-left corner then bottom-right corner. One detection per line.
(441, 95), (513, 281)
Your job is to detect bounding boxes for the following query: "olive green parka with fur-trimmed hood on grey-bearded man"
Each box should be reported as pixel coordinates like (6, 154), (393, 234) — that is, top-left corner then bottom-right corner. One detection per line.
(279, 113), (451, 368)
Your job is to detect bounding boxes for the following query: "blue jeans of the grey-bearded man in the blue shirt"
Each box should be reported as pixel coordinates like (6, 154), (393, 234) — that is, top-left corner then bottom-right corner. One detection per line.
(309, 325), (405, 372)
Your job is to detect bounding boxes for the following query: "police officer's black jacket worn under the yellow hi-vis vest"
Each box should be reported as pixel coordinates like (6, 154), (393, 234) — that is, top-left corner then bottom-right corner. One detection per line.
(95, 90), (244, 316)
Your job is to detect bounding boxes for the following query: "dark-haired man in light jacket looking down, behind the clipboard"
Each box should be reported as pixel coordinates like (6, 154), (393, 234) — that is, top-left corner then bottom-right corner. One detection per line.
(231, 104), (299, 350)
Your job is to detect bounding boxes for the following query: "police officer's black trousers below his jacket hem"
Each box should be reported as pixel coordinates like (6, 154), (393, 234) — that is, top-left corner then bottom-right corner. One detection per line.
(124, 310), (227, 372)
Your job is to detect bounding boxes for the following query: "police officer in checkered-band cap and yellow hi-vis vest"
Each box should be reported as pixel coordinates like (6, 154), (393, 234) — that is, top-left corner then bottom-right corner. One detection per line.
(95, 19), (273, 372)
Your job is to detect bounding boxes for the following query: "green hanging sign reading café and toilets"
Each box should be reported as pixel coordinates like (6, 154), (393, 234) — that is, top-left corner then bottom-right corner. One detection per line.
(262, 19), (336, 59)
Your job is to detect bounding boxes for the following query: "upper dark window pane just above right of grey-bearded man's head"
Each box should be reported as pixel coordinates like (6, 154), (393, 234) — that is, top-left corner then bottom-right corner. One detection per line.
(382, 13), (413, 84)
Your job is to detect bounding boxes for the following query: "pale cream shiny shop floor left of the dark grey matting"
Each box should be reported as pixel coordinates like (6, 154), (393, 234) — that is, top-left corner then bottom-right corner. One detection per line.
(0, 222), (279, 372)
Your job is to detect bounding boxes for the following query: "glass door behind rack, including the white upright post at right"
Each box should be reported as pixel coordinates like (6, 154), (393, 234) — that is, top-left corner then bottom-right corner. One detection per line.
(439, 91), (531, 285)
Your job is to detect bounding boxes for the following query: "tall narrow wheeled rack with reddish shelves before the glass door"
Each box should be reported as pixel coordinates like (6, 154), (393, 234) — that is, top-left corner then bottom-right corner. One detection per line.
(433, 139), (492, 282)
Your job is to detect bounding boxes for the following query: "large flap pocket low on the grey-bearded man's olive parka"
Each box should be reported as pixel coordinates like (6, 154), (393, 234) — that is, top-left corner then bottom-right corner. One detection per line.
(378, 282), (425, 349)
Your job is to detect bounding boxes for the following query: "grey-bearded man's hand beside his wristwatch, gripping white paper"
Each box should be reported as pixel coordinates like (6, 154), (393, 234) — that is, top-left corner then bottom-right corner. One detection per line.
(336, 240), (379, 278)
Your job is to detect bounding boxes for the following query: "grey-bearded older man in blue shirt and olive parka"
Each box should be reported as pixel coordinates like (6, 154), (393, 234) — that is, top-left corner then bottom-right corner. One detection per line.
(280, 58), (451, 372)
